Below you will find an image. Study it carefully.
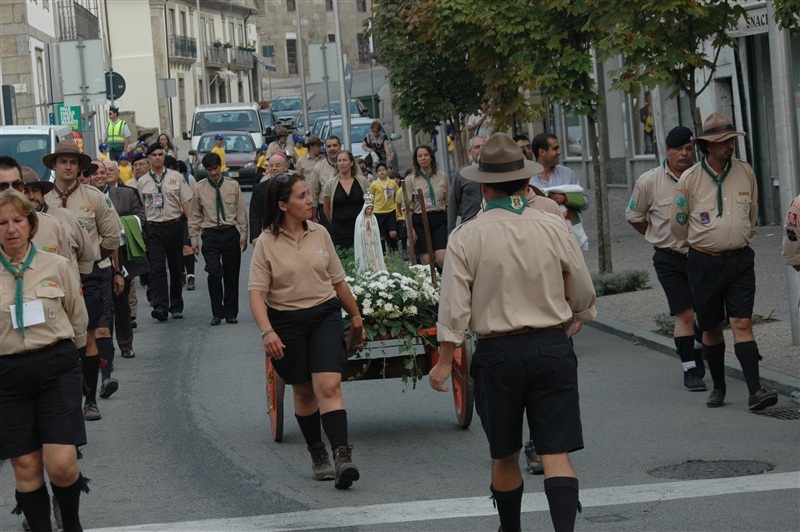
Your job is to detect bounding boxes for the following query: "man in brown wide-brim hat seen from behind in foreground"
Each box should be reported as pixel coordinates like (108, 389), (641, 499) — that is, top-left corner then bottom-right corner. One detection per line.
(429, 133), (597, 530)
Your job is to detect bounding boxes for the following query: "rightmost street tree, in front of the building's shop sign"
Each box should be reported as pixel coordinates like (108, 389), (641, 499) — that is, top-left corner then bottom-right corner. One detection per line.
(598, 0), (746, 132)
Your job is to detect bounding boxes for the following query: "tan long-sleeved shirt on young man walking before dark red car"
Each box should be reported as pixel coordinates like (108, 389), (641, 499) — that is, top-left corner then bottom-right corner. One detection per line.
(189, 177), (247, 245)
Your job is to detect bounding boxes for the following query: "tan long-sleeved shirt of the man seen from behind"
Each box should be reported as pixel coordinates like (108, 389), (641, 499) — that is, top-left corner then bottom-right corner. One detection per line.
(436, 204), (597, 344)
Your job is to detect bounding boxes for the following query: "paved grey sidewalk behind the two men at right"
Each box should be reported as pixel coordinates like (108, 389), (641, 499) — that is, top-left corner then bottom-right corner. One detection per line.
(584, 188), (800, 396)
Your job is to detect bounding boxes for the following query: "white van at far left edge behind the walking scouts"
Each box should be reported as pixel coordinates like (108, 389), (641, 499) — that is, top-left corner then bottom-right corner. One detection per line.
(0, 126), (72, 181)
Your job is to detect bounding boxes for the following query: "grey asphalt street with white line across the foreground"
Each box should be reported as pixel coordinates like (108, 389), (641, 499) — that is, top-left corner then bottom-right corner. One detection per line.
(0, 190), (800, 531)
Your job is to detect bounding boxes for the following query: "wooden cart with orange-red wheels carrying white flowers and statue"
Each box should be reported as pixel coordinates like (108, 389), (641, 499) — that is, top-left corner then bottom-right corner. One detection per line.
(265, 328), (474, 442)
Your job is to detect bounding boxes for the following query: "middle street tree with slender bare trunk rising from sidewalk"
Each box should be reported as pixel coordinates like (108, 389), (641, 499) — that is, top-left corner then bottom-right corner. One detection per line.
(409, 0), (617, 273)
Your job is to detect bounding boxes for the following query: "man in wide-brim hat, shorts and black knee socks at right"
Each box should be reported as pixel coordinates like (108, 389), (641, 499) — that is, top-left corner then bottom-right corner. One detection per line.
(670, 113), (778, 410)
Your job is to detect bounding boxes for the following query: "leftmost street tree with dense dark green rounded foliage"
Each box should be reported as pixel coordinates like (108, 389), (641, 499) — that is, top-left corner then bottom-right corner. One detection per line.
(372, 0), (484, 164)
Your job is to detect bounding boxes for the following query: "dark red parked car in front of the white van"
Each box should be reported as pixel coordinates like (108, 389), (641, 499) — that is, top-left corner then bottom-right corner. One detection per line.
(188, 131), (257, 188)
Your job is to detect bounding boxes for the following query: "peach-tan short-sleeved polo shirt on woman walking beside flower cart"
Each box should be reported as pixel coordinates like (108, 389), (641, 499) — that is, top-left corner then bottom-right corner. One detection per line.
(248, 222), (345, 310)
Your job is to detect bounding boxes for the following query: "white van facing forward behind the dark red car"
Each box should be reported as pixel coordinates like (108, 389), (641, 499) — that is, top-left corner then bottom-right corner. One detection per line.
(184, 103), (270, 150)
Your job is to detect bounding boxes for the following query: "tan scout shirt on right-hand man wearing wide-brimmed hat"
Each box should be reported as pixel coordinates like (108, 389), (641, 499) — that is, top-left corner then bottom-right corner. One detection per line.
(670, 159), (758, 252)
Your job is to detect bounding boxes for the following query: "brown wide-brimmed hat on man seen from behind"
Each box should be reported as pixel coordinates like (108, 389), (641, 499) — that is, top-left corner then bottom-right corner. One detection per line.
(461, 133), (544, 183)
